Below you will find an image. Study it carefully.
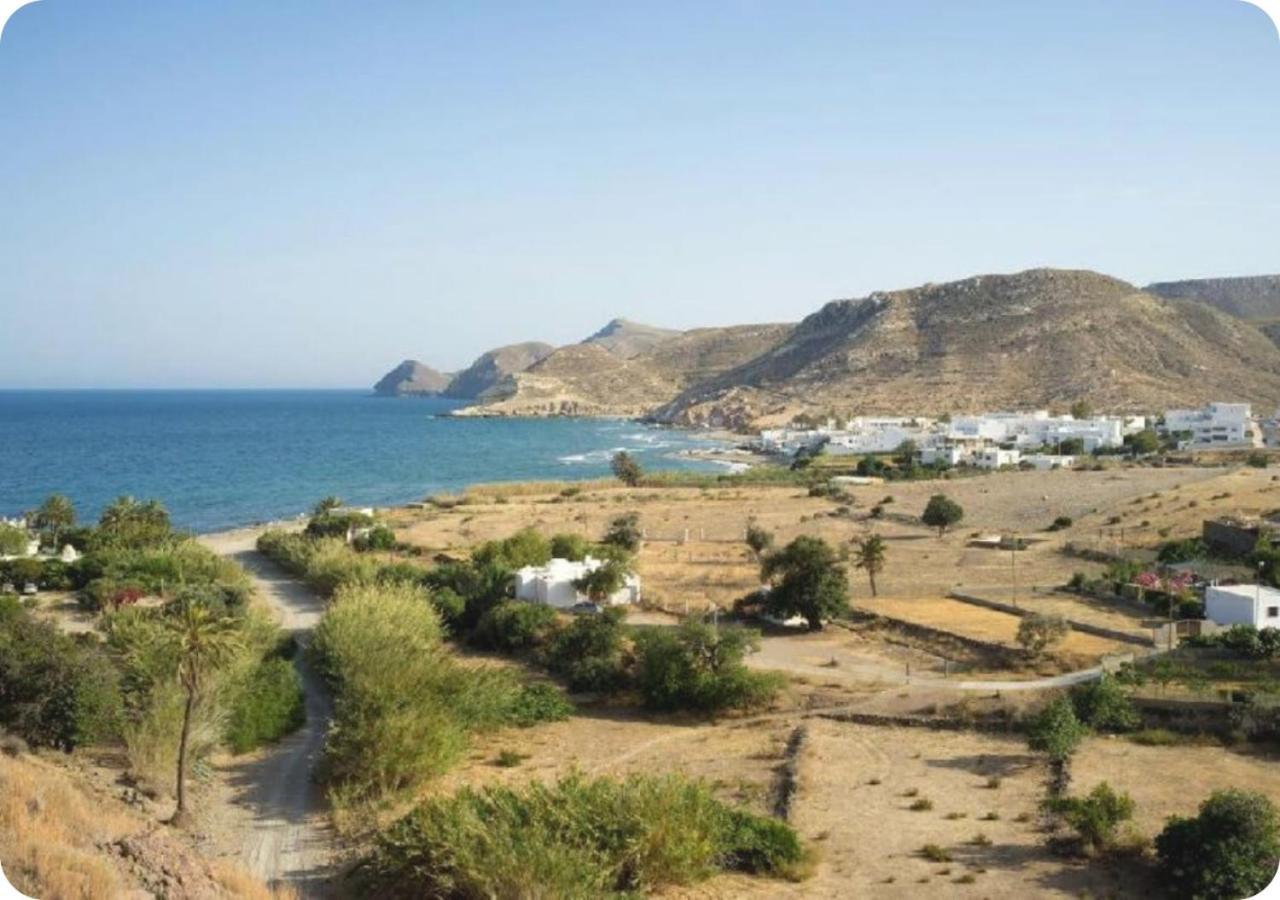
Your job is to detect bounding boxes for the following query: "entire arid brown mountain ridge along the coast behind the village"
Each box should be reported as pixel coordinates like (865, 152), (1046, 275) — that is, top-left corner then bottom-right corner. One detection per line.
(379, 269), (1280, 429)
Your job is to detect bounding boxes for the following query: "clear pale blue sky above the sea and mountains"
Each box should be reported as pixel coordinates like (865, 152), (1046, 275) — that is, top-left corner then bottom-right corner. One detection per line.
(0, 0), (1280, 388)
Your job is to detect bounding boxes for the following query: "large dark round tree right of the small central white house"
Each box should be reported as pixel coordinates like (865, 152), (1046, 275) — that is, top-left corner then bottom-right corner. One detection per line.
(763, 535), (849, 631)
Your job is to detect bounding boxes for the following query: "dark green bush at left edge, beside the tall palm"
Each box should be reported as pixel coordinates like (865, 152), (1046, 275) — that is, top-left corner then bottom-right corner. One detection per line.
(0, 597), (123, 750)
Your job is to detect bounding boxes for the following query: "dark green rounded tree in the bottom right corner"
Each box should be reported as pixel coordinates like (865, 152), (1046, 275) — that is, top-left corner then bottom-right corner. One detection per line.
(1156, 789), (1280, 900)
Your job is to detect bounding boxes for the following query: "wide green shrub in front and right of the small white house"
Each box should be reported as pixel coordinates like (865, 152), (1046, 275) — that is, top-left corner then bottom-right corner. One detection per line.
(635, 620), (781, 712)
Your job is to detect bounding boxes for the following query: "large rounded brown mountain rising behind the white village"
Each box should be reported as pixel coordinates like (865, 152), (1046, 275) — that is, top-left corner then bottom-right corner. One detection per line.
(654, 269), (1280, 426)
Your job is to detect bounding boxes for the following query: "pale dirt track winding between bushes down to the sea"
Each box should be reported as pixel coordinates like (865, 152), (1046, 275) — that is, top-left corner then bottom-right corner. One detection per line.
(201, 530), (334, 897)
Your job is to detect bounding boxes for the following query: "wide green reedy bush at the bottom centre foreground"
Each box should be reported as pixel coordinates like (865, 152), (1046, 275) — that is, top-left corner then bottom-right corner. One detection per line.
(364, 775), (806, 897)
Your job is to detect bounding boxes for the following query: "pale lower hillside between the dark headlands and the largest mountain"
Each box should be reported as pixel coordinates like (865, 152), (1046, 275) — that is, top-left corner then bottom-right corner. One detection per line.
(450, 323), (791, 416)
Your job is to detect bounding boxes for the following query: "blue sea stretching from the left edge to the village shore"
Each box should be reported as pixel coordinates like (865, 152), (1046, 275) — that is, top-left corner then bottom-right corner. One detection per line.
(0, 390), (732, 531)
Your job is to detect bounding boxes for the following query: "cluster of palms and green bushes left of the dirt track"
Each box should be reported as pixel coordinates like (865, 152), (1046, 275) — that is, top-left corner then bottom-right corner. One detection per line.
(0, 497), (303, 823)
